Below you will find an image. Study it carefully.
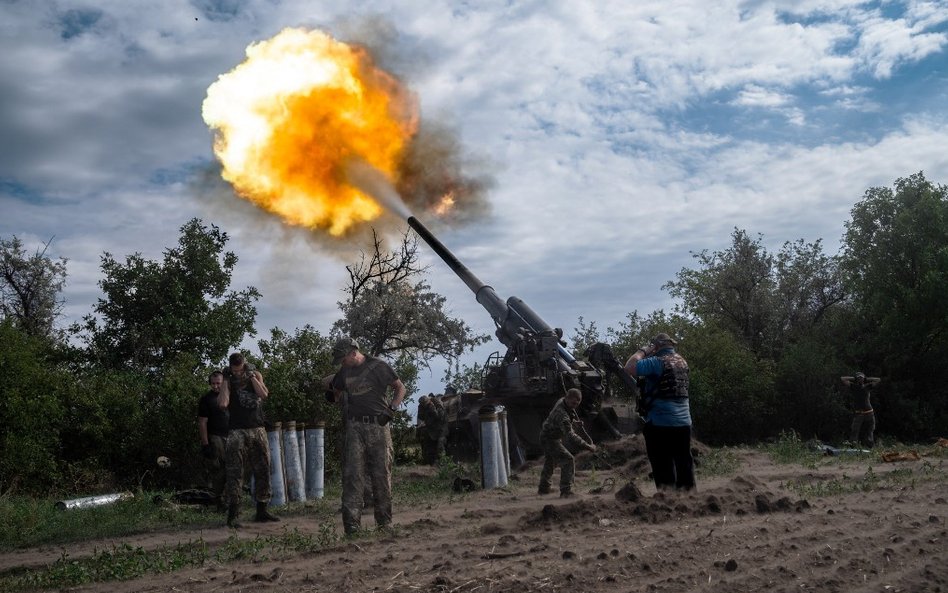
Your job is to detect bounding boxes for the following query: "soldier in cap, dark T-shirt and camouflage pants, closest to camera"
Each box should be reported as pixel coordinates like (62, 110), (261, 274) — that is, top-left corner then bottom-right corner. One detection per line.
(327, 336), (405, 535)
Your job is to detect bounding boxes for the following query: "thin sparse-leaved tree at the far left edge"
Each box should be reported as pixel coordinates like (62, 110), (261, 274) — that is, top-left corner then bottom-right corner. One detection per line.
(0, 236), (66, 338)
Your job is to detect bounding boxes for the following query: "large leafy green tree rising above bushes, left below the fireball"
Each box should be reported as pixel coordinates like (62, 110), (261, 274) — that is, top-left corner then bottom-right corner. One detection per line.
(73, 218), (260, 371)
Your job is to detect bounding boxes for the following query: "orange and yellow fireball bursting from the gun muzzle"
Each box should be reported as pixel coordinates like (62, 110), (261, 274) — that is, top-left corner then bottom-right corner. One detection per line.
(202, 29), (418, 236)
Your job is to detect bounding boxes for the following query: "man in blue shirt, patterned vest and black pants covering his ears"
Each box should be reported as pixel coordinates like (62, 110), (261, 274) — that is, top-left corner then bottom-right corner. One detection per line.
(625, 333), (695, 490)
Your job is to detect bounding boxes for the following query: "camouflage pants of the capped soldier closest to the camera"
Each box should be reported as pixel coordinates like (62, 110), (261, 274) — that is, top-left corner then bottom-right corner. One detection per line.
(342, 421), (394, 533)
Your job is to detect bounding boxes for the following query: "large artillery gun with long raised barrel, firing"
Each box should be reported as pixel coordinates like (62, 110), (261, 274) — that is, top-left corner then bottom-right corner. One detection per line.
(408, 216), (639, 465)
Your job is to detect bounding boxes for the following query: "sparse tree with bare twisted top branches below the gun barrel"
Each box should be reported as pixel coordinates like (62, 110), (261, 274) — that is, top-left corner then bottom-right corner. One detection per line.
(333, 228), (488, 366)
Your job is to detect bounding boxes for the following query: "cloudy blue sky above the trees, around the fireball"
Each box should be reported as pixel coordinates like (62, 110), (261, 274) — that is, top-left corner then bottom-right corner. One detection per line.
(0, 0), (948, 402)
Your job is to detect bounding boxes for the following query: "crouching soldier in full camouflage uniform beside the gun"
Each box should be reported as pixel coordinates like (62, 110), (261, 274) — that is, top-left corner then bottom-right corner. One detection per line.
(537, 388), (596, 498)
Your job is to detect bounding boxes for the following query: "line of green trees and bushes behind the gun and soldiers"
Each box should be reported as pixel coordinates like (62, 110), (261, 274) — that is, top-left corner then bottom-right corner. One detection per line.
(0, 173), (948, 493)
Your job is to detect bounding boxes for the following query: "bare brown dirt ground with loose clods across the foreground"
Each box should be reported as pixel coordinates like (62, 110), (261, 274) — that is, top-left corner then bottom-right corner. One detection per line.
(0, 437), (948, 593)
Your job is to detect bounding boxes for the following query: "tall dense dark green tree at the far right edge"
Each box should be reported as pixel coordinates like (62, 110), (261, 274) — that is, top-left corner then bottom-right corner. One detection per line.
(842, 172), (948, 438)
